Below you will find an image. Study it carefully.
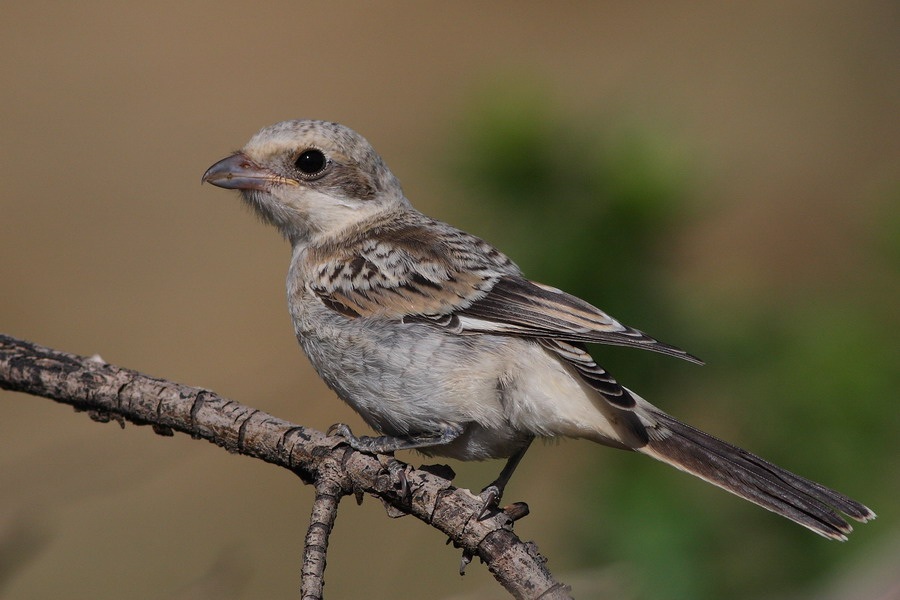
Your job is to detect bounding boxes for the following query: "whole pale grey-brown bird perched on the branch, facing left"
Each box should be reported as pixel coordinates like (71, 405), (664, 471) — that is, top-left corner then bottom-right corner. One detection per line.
(203, 120), (875, 540)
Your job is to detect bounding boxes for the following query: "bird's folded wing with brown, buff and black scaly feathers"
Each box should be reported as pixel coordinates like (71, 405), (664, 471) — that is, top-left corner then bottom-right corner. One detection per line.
(309, 220), (701, 363)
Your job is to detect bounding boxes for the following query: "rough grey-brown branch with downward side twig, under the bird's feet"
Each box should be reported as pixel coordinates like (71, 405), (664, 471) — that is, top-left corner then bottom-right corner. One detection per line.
(0, 334), (570, 599)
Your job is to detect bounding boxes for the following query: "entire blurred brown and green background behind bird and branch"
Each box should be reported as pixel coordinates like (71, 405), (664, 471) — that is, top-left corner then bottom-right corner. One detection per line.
(0, 0), (900, 600)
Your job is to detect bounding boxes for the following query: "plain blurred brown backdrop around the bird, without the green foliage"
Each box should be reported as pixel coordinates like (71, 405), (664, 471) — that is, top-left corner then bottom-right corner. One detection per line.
(0, 0), (900, 599)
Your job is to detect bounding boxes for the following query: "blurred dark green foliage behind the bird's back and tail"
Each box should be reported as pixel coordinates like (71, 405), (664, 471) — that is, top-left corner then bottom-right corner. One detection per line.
(448, 86), (900, 600)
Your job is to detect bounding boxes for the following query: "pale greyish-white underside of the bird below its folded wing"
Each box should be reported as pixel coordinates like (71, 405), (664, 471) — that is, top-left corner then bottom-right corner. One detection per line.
(291, 286), (632, 460)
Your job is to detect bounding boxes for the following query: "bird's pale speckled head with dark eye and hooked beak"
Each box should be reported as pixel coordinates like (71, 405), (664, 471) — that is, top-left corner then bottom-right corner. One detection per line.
(203, 120), (409, 244)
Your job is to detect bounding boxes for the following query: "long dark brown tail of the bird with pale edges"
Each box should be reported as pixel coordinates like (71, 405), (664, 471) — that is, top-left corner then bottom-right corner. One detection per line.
(639, 412), (875, 541)
